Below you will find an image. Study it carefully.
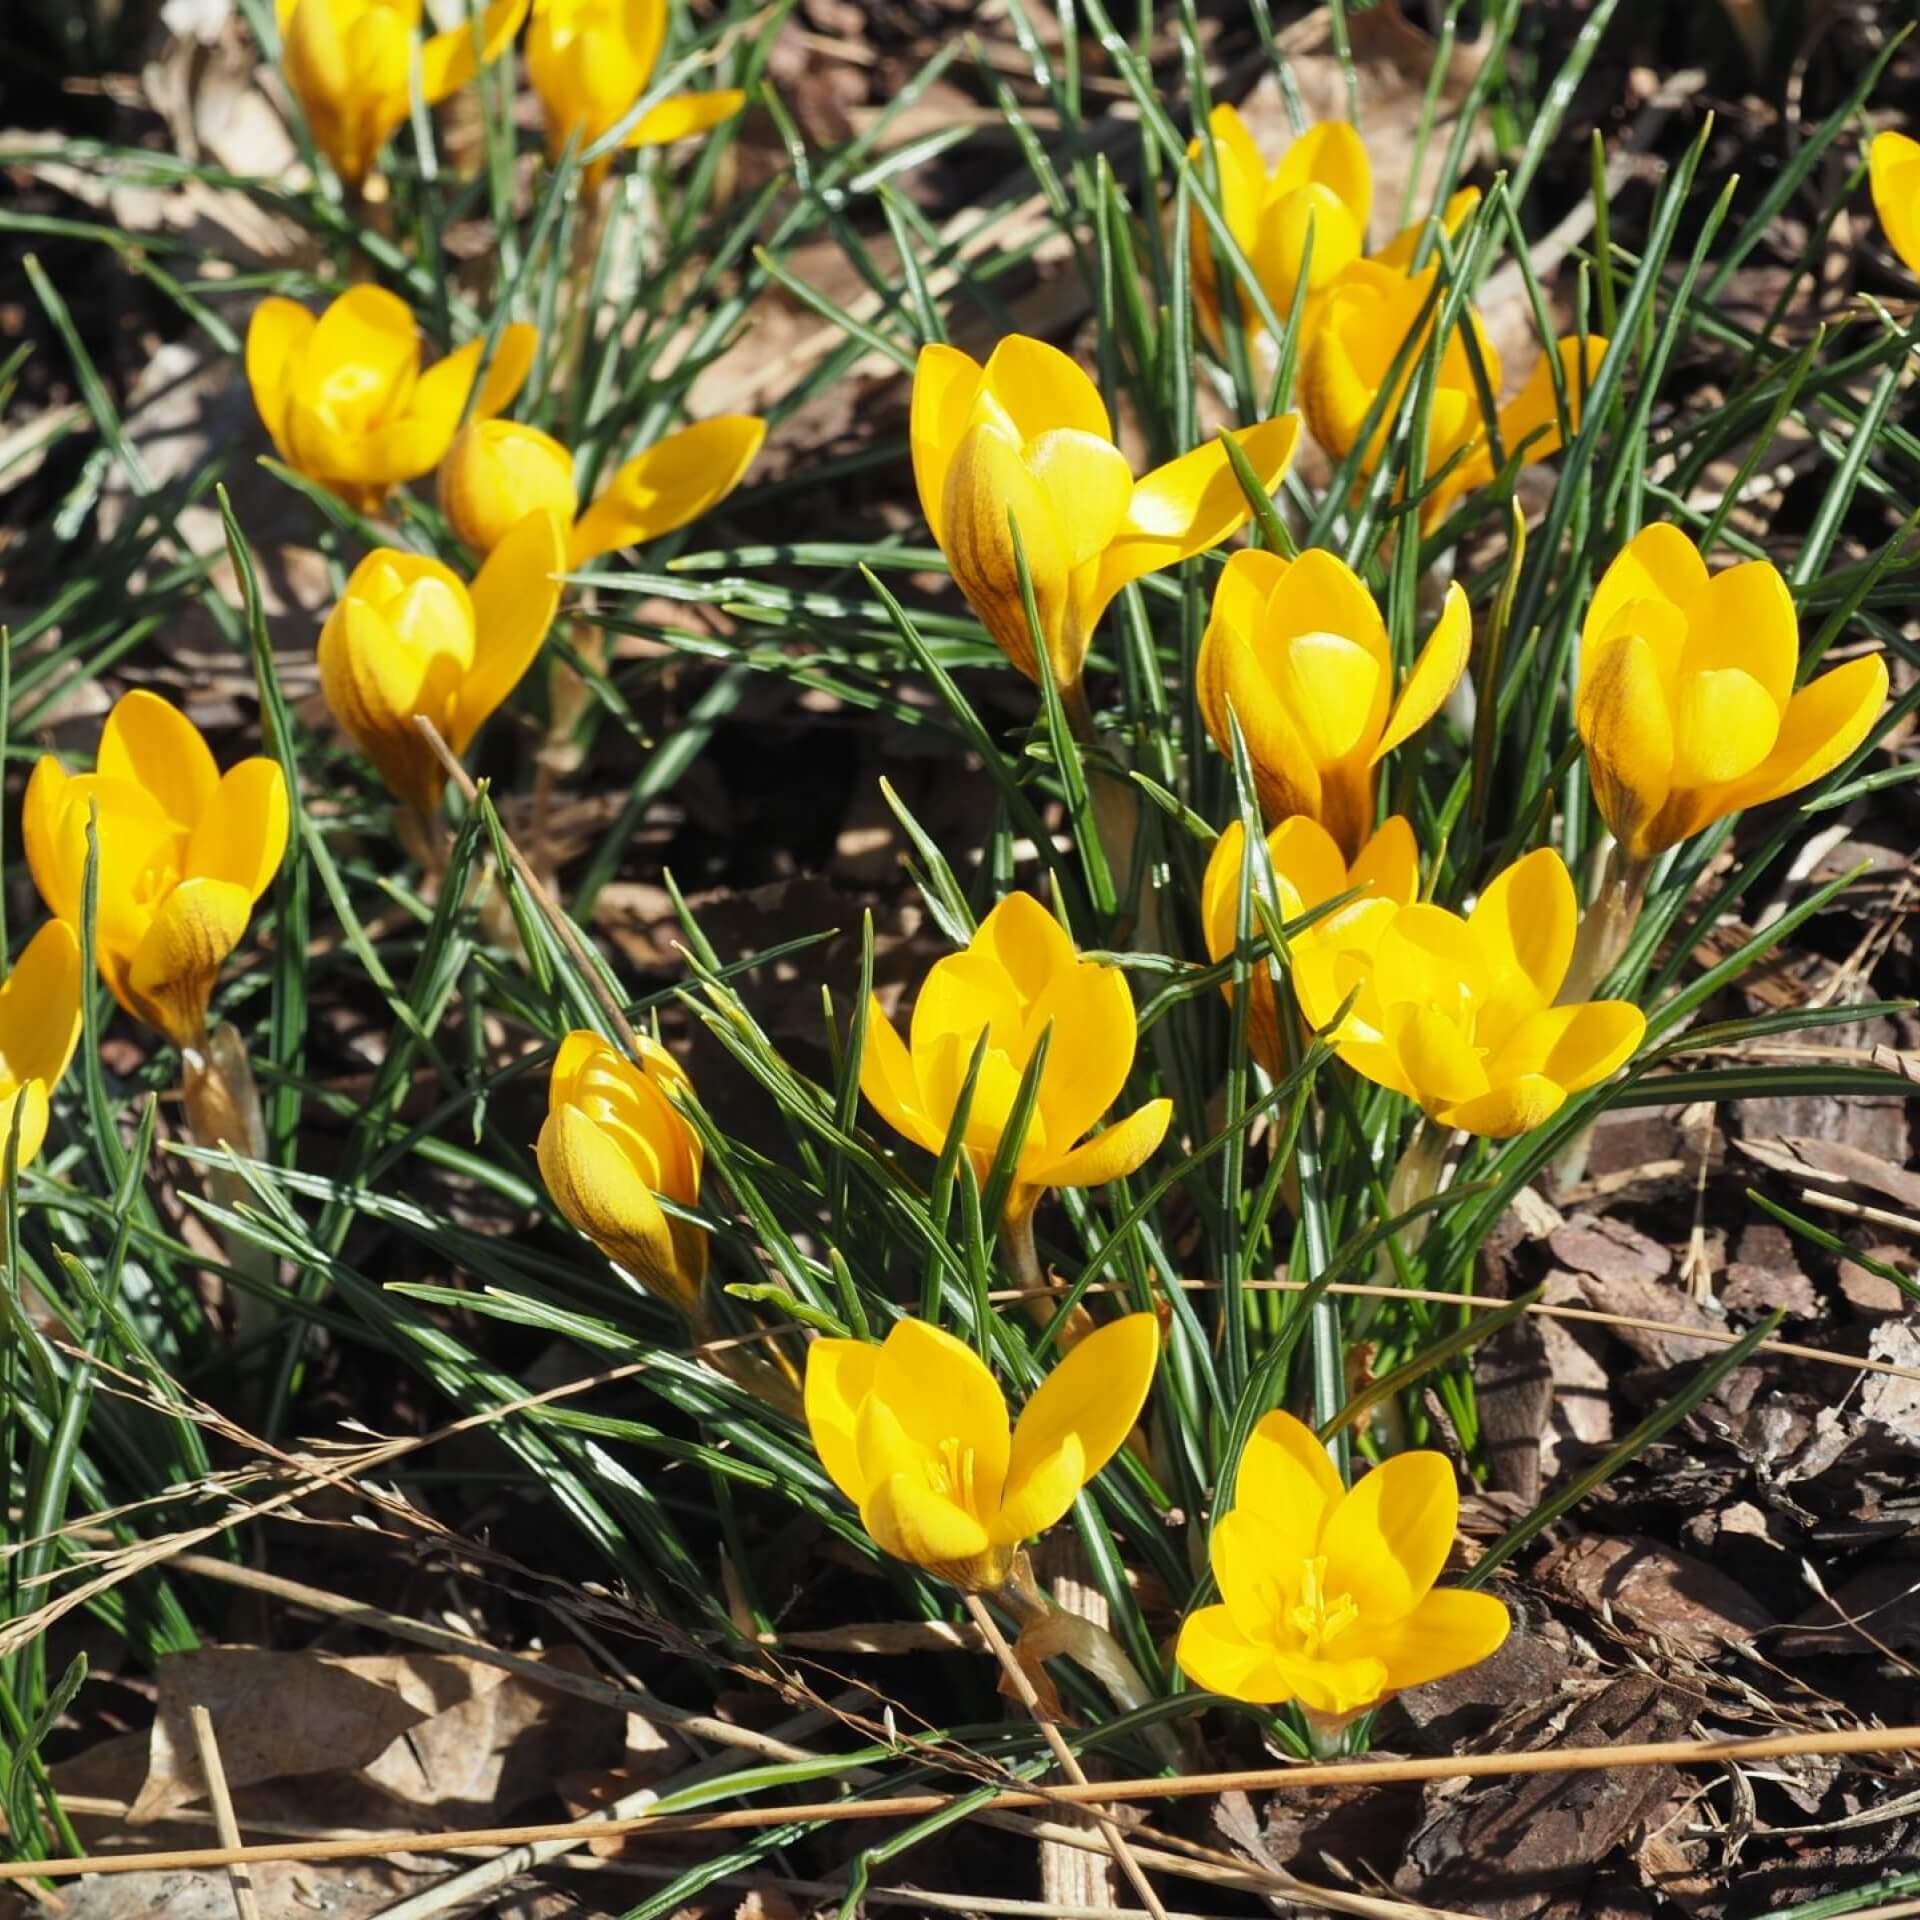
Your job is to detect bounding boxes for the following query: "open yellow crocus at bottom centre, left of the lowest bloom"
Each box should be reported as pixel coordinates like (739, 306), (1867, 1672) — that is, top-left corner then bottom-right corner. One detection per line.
(806, 1313), (1160, 1594)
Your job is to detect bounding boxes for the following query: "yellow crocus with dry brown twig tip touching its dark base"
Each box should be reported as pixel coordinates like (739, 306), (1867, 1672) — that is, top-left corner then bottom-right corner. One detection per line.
(321, 513), (566, 818)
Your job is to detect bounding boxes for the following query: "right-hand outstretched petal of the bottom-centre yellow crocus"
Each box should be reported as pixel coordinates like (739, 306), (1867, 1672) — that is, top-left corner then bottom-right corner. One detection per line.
(995, 1313), (1160, 1544)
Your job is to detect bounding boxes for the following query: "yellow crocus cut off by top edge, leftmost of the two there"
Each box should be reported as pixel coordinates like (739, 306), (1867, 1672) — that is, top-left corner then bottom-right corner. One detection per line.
(275, 0), (526, 186)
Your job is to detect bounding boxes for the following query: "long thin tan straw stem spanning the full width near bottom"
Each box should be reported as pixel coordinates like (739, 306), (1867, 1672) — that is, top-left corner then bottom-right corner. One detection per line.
(0, 1726), (1920, 1882)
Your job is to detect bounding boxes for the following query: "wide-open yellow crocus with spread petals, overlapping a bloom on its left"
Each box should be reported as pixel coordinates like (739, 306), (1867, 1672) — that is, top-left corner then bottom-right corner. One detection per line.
(1294, 847), (1647, 1140)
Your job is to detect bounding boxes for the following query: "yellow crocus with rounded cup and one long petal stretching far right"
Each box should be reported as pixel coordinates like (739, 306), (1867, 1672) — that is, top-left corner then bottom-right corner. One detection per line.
(440, 413), (766, 568)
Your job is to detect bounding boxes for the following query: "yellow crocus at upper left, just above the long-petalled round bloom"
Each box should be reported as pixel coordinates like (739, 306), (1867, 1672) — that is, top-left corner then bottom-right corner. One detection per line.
(246, 284), (540, 513)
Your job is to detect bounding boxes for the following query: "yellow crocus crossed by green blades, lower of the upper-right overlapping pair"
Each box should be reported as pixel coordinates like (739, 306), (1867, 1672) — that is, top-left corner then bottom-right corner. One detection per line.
(1300, 253), (1607, 530)
